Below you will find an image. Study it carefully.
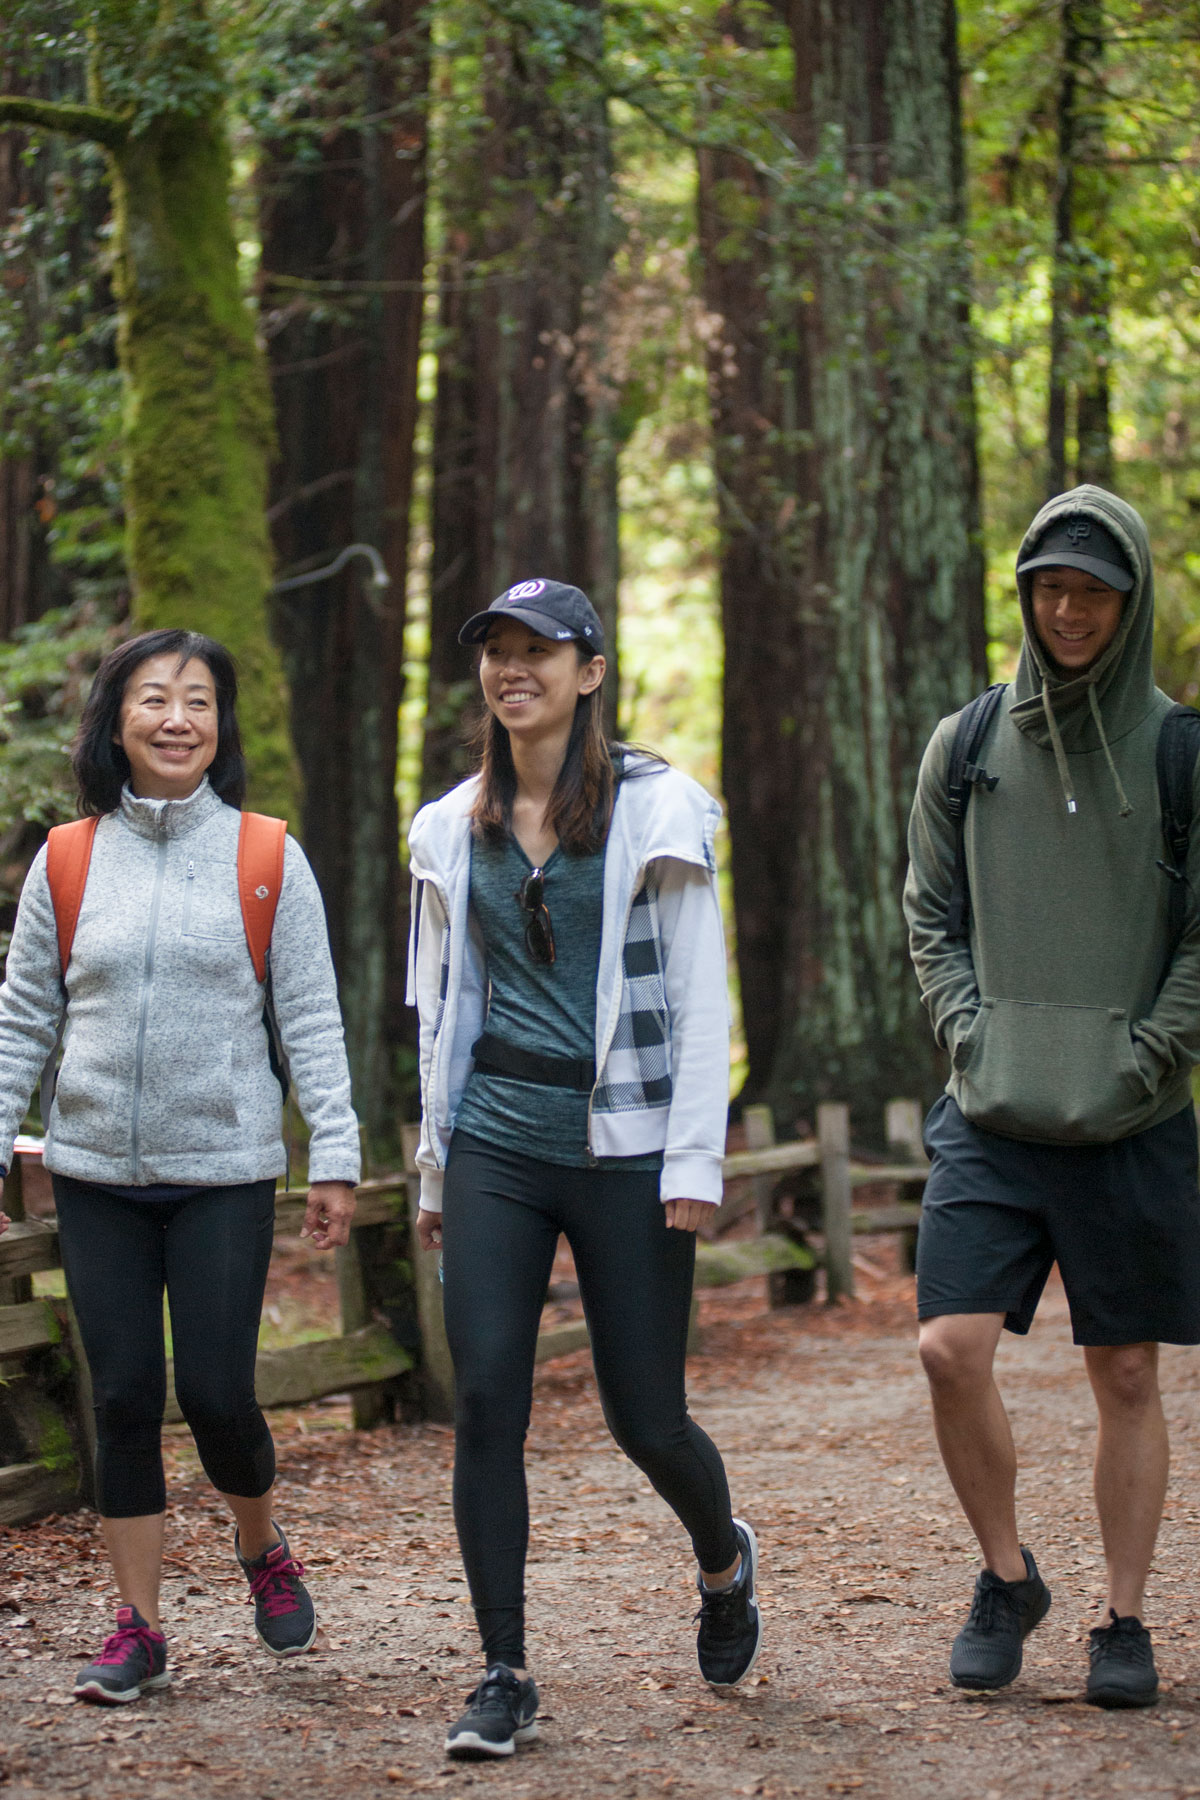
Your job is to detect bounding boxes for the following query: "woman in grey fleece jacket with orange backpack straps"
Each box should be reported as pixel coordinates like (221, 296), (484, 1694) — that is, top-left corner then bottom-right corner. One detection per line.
(0, 630), (358, 1705)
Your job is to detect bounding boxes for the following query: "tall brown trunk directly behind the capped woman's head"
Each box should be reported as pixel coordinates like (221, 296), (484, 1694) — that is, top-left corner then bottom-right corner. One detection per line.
(423, 0), (617, 794)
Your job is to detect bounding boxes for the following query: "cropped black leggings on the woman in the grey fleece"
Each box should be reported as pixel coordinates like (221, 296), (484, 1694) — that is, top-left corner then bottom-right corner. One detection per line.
(54, 1175), (275, 1519)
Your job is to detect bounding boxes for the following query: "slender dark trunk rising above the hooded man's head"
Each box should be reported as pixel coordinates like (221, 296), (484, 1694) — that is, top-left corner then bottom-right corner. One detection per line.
(1047, 0), (1112, 497)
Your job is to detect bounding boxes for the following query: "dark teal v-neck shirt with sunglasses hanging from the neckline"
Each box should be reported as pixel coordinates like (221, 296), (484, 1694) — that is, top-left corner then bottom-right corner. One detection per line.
(455, 833), (662, 1170)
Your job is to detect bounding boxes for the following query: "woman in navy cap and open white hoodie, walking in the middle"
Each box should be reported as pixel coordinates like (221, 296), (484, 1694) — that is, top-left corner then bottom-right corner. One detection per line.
(410, 581), (761, 1757)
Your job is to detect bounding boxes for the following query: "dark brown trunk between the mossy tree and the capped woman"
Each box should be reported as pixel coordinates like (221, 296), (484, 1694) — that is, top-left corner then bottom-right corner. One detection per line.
(261, 0), (428, 1143)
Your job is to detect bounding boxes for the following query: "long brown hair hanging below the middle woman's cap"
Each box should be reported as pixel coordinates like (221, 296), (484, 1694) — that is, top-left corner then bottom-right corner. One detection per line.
(471, 643), (622, 857)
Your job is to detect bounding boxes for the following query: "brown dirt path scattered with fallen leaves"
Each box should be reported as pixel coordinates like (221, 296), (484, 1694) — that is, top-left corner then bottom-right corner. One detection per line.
(0, 1246), (1200, 1800)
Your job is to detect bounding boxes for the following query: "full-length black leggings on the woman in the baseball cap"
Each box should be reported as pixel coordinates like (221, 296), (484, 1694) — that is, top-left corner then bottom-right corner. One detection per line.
(443, 1132), (738, 1669)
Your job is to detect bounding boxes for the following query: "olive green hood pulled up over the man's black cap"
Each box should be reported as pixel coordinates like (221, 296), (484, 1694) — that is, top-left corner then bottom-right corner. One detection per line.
(1009, 484), (1155, 751)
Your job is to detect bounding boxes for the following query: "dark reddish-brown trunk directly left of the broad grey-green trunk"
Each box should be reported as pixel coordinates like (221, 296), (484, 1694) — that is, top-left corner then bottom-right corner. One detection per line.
(698, 5), (813, 1100)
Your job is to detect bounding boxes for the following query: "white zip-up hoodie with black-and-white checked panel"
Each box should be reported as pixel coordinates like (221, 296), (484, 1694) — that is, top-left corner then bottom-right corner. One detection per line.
(408, 754), (729, 1211)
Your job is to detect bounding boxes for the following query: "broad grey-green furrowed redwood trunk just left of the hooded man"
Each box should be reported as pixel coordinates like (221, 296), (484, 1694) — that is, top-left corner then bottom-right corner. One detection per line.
(705, 0), (986, 1139)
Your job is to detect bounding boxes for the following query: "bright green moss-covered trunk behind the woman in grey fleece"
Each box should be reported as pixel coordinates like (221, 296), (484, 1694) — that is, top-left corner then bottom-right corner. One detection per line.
(0, 0), (297, 817)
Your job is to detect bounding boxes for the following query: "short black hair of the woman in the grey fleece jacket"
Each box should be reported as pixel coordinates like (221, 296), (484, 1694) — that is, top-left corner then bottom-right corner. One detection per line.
(70, 630), (246, 814)
